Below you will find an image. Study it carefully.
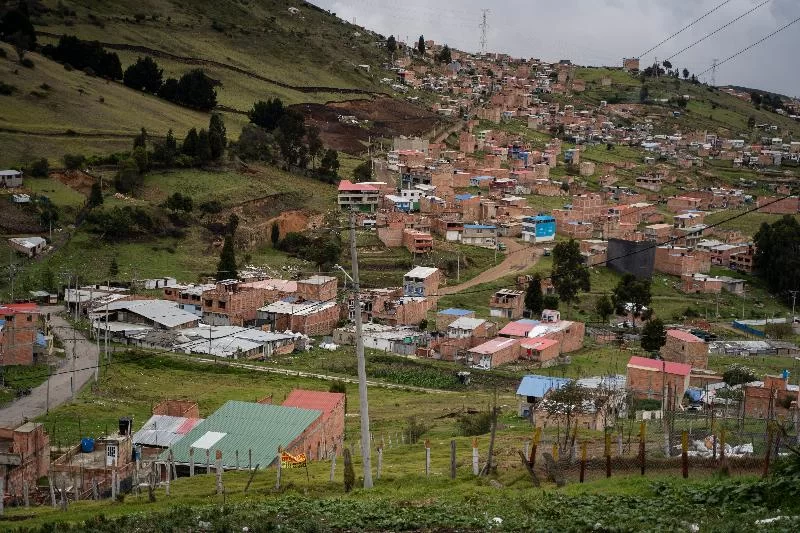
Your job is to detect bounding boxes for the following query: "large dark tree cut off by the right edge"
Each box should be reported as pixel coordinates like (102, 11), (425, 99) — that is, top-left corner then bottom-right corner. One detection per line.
(753, 215), (800, 294)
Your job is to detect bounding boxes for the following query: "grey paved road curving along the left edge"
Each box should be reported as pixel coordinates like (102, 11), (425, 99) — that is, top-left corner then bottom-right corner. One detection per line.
(0, 306), (98, 427)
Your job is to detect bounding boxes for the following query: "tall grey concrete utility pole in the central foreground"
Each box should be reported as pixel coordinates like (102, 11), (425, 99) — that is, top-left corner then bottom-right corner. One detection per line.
(350, 210), (372, 489)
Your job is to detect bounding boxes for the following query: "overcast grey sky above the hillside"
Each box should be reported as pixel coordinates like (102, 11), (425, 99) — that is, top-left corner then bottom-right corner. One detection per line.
(312, 0), (800, 96)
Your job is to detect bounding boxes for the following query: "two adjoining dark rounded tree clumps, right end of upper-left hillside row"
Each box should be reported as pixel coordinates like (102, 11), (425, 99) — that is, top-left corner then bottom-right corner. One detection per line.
(122, 56), (217, 111)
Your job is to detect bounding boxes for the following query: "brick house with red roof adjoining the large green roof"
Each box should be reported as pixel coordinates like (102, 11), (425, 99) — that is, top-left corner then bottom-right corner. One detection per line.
(281, 389), (346, 460)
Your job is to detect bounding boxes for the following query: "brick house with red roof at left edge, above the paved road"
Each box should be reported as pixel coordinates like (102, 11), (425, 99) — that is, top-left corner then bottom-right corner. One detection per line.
(0, 304), (41, 366)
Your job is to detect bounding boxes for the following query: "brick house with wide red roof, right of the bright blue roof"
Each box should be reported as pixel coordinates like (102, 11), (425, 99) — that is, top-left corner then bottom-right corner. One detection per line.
(627, 356), (692, 400)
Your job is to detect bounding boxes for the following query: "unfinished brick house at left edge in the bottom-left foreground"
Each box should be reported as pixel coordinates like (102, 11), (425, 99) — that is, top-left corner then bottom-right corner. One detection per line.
(0, 422), (50, 501)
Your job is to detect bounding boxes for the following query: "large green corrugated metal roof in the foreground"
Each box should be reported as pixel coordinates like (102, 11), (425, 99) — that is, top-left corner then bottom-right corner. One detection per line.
(159, 400), (322, 468)
